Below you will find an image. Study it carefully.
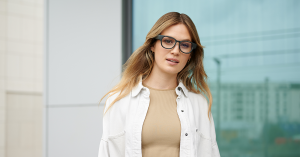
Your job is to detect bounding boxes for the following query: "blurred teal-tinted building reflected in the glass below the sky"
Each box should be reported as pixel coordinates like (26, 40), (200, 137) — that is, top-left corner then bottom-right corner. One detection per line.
(210, 82), (300, 139)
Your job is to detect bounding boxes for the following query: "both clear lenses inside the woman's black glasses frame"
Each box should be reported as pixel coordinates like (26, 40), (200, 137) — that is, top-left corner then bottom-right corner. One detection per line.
(161, 37), (192, 53)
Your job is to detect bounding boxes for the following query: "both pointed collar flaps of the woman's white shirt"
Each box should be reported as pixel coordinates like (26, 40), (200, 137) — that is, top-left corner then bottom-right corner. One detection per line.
(131, 79), (188, 97)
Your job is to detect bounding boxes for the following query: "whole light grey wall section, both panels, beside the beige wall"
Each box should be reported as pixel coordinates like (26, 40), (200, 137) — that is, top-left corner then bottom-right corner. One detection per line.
(44, 0), (122, 157)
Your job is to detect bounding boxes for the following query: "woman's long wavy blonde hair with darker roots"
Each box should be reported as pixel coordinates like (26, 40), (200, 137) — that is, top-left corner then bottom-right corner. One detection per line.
(100, 12), (212, 118)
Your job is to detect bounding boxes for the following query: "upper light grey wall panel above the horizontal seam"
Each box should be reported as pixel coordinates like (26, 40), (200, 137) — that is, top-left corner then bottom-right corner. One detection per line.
(47, 0), (122, 105)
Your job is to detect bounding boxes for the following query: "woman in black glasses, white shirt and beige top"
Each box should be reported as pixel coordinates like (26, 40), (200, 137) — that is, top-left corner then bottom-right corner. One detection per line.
(99, 12), (220, 157)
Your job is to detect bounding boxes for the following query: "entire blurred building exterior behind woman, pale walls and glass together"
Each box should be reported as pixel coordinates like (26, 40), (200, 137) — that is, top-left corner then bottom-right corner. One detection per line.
(0, 0), (300, 157)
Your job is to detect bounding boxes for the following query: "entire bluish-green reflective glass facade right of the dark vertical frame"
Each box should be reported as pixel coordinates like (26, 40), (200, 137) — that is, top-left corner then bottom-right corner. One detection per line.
(132, 0), (300, 157)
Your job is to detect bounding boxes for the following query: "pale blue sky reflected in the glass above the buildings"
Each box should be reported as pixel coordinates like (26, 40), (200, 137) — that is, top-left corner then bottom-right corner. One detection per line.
(133, 0), (300, 83)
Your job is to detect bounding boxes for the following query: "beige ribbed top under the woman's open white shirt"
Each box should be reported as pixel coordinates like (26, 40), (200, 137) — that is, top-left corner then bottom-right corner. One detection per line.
(142, 85), (181, 157)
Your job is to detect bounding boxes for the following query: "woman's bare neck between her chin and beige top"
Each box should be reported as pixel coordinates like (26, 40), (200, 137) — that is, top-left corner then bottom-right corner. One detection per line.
(143, 68), (178, 90)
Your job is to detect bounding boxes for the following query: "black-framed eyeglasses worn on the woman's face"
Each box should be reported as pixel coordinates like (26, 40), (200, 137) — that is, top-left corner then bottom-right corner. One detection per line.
(155, 35), (197, 54)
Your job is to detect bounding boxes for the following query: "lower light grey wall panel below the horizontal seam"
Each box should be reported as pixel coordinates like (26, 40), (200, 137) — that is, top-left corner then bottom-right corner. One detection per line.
(47, 106), (103, 157)
